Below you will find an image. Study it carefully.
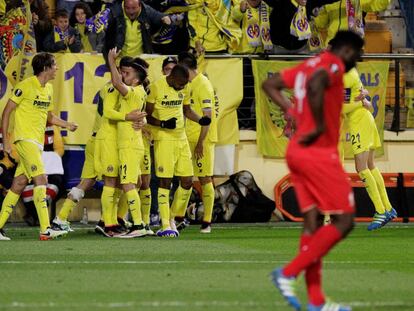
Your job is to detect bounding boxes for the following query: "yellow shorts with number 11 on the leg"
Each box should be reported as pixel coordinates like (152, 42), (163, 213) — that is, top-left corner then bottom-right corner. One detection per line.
(119, 148), (144, 184)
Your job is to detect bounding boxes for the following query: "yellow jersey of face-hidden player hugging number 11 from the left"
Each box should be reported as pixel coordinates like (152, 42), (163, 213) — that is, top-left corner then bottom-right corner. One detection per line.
(96, 82), (125, 140)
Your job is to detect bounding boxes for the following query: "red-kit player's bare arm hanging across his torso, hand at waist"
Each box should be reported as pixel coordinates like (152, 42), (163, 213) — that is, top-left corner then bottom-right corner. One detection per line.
(299, 69), (329, 146)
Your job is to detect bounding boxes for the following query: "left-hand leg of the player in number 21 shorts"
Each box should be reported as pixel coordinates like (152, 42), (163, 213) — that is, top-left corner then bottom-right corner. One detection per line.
(354, 151), (387, 230)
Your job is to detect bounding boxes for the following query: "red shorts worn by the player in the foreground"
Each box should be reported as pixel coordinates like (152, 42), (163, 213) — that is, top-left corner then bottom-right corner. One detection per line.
(286, 148), (355, 214)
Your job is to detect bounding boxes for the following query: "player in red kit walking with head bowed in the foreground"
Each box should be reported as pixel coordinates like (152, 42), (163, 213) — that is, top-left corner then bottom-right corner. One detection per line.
(263, 31), (364, 311)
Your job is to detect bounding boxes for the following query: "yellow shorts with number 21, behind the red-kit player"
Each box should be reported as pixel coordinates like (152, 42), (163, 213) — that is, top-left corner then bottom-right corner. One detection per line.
(348, 109), (381, 155)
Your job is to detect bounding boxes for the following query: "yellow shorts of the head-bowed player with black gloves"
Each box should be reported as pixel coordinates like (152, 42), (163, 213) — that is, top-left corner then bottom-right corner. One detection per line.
(154, 139), (193, 178)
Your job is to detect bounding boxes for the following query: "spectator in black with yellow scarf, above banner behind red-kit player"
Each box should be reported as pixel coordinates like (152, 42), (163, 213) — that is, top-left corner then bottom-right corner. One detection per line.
(265, 0), (338, 54)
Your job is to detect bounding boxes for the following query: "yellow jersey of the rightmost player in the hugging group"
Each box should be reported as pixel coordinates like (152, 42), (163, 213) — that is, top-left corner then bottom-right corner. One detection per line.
(185, 73), (218, 142)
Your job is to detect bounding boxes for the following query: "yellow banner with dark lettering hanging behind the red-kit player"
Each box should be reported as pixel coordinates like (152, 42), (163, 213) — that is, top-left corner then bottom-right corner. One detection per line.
(252, 60), (389, 158)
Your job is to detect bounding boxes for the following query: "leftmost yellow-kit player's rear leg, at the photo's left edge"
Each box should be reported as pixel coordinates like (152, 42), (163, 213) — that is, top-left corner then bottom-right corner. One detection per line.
(0, 173), (28, 241)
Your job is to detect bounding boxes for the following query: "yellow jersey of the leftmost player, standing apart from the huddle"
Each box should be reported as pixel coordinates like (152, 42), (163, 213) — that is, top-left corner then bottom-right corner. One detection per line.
(10, 76), (53, 146)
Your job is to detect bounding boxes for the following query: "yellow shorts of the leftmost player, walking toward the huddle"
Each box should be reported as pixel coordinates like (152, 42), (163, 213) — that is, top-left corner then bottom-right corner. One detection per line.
(14, 140), (45, 181)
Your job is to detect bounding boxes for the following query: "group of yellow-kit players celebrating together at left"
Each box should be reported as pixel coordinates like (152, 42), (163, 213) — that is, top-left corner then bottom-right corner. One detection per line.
(0, 49), (218, 240)
